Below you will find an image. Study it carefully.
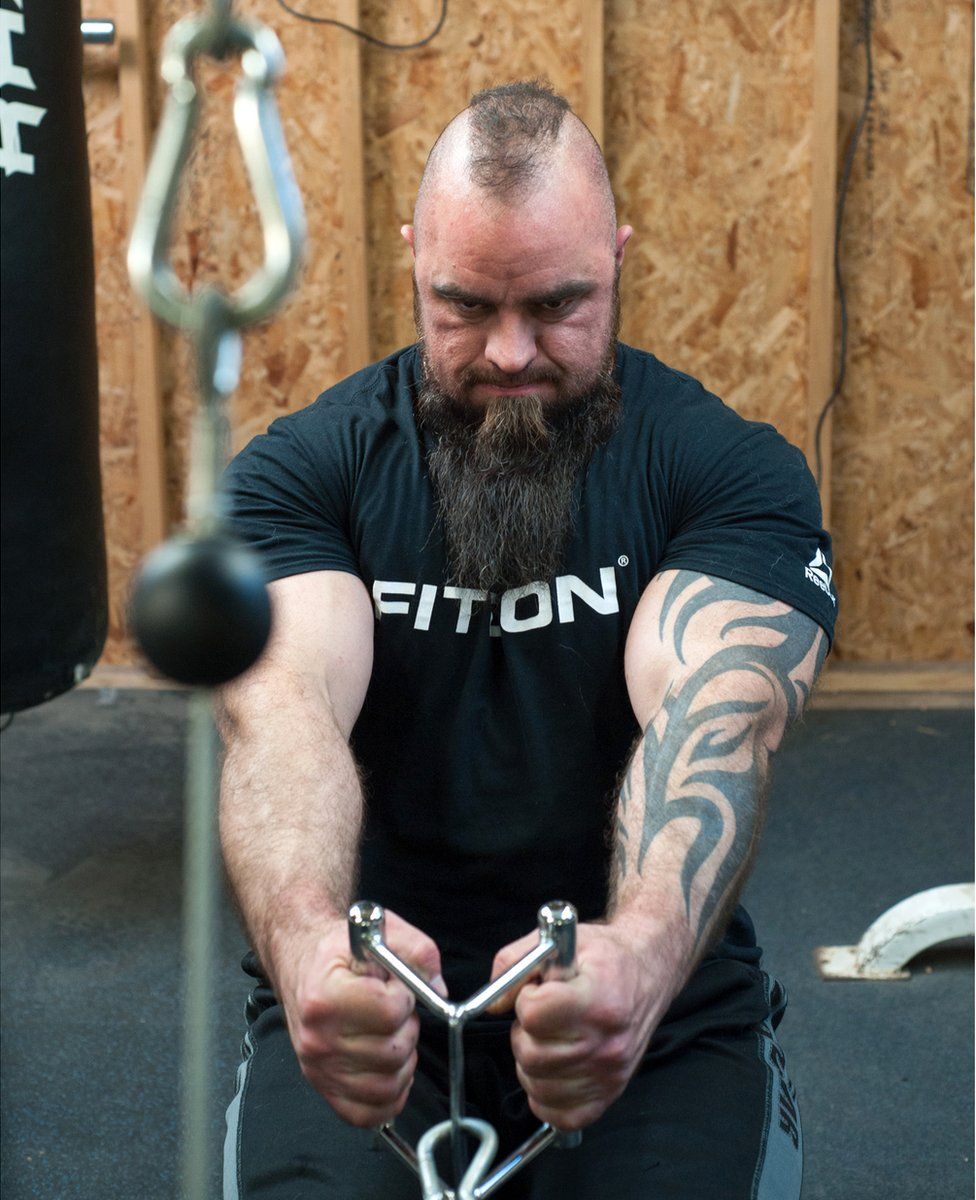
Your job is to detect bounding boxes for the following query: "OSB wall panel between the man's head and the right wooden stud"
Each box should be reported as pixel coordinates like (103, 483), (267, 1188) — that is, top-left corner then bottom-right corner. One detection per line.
(606, 0), (814, 445)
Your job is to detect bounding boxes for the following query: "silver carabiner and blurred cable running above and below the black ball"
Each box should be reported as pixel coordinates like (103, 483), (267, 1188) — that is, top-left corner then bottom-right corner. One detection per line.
(128, 7), (305, 1200)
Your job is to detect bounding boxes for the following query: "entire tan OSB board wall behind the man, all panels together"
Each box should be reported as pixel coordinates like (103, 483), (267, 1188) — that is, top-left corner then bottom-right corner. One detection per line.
(79, 0), (972, 664)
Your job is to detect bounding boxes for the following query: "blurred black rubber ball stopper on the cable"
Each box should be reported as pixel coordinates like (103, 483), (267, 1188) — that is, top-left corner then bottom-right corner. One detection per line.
(130, 534), (271, 688)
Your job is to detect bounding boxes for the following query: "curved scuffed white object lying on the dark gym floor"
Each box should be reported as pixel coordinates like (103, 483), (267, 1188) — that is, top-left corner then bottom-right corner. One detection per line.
(814, 883), (976, 979)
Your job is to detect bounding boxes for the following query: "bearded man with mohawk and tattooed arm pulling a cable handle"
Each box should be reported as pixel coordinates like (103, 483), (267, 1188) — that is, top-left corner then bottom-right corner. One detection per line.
(221, 83), (836, 1200)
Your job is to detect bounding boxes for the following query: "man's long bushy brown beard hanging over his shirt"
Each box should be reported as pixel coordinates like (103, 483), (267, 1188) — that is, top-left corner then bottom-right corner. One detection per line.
(417, 345), (621, 593)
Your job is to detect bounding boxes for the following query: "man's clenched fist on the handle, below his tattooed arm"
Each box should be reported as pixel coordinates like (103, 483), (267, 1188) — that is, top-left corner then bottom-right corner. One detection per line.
(492, 924), (672, 1130)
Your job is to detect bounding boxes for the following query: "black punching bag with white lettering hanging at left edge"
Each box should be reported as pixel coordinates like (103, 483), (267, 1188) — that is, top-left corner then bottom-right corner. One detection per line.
(0, 0), (108, 713)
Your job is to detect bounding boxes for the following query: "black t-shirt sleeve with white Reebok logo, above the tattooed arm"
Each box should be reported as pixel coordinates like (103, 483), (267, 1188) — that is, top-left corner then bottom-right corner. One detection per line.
(658, 390), (837, 643)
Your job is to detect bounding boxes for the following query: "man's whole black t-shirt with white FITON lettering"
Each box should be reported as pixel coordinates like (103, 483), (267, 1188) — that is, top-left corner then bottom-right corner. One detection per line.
(226, 346), (836, 998)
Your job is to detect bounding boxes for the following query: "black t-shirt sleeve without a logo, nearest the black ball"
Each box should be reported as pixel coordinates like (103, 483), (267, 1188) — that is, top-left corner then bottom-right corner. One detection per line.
(222, 414), (360, 582)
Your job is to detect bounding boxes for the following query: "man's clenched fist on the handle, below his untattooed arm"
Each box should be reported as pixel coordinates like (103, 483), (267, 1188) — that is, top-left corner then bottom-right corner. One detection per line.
(276, 911), (447, 1128)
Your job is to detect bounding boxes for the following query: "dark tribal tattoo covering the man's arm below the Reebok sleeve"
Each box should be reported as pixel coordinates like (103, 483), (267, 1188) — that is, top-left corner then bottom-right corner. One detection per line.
(613, 571), (827, 952)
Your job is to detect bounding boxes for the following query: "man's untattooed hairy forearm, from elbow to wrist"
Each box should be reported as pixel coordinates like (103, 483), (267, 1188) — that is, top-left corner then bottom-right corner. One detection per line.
(220, 689), (363, 978)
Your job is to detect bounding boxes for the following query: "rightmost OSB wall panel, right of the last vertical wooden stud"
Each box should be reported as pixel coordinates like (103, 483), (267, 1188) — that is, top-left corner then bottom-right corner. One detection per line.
(833, 0), (974, 660)
